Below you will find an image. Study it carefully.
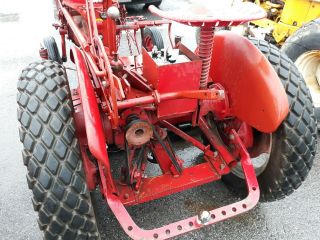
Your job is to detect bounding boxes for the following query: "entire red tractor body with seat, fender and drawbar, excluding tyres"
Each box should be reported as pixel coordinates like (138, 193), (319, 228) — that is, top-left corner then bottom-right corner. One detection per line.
(21, 0), (308, 239)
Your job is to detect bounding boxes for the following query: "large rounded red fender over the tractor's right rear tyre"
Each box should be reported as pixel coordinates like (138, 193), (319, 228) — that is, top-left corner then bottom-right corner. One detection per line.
(210, 31), (289, 133)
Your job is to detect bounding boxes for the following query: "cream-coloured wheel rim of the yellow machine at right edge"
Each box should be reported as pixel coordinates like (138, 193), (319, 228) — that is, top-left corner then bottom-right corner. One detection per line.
(295, 50), (320, 108)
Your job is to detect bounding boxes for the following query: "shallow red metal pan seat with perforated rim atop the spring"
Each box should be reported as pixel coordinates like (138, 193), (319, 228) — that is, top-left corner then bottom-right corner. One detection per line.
(149, 1), (266, 27)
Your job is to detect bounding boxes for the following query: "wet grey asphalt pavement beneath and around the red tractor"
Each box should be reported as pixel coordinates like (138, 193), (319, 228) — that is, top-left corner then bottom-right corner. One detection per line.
(0, 0), (320, 240)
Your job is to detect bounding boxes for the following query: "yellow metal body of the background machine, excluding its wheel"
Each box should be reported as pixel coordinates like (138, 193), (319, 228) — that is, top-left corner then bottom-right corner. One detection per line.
(253, 0), (320, 45)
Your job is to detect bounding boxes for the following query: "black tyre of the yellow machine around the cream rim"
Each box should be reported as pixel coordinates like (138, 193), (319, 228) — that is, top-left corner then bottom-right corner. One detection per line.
(281, 18), (320, 122)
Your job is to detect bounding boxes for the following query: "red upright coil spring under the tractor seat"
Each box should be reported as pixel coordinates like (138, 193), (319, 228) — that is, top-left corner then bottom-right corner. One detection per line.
(199, 28), (214, 89)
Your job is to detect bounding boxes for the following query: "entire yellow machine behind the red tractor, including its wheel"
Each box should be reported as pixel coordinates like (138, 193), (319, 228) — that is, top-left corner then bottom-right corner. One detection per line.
(249, 0), (320, 121)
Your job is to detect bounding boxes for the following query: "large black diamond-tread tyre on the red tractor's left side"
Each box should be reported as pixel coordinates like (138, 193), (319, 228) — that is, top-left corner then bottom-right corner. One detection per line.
(17, 60), (99, 239)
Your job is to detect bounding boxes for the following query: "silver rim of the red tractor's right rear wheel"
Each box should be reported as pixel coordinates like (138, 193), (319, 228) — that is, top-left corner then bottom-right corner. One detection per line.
(231, 134), (272, 179)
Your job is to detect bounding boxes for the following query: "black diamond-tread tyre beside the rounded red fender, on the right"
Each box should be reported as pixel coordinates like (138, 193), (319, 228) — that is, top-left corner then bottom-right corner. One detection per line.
(222, 39), (317, 201)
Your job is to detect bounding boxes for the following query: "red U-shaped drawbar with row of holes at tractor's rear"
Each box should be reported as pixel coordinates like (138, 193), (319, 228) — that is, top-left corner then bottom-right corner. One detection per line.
(103, 131), (260, 239)
